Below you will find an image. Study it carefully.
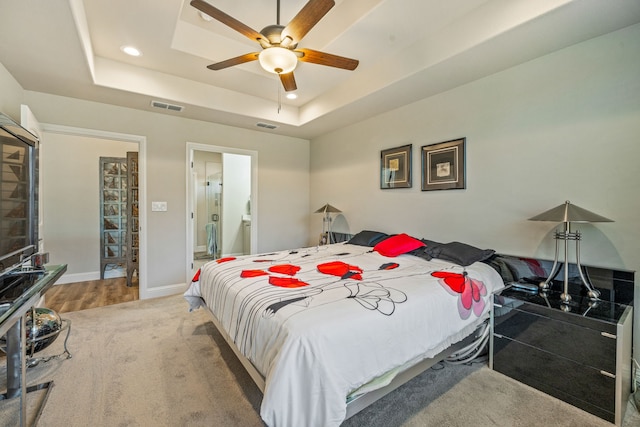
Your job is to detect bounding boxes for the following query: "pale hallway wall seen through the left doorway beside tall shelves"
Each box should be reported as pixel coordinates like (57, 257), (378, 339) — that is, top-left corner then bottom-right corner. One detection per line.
(40, 133), (138, 283)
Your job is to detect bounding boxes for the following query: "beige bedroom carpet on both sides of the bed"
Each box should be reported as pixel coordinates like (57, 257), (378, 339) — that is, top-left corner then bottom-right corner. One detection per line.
(0, 296), (640, 427)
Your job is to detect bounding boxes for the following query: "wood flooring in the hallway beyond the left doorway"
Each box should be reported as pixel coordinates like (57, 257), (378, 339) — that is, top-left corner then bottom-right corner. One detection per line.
(44, 277), (139, 313)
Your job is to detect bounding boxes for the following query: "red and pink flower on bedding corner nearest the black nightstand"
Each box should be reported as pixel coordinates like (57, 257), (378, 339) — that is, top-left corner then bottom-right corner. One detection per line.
(431, 271), (487, 319)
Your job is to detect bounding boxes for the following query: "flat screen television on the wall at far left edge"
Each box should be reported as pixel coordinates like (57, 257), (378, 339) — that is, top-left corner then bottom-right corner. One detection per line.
(0, 113), (38, 276)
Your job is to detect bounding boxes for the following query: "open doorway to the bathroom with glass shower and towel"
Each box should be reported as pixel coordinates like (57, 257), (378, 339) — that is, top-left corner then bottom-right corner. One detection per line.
(187, 143), (257, 280)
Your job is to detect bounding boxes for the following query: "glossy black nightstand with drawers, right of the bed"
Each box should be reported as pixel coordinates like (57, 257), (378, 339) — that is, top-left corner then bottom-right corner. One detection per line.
(489, 287), (633, 426)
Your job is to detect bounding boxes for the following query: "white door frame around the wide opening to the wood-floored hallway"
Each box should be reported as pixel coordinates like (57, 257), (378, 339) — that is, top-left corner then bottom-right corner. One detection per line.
(41, 123), (148, 299)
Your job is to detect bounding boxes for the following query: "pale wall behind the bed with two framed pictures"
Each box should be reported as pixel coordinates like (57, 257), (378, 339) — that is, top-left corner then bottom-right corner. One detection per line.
(309, 25), (640, 360)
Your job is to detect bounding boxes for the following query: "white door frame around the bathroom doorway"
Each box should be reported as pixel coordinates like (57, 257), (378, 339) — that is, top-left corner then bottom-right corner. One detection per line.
(185, 142), (258, 283)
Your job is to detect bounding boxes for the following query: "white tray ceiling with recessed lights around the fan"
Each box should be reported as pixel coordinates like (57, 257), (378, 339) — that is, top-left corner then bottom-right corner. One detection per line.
(0, 0), (640, 139)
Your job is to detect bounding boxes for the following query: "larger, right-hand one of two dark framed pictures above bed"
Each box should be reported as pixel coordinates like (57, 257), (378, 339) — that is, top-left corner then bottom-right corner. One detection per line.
(422, 138), (466, 191)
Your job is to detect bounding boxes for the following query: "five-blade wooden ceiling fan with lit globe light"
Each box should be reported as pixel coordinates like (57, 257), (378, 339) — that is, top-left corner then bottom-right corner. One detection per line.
(191, 0), (359, 92)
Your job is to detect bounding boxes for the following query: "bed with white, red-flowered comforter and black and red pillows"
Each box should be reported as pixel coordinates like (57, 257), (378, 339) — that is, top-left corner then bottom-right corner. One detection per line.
(185, 230), (504, 427)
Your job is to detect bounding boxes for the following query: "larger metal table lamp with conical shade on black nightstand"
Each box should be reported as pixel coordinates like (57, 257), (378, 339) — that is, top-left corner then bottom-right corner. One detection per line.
(529, 200), (613, 303)
